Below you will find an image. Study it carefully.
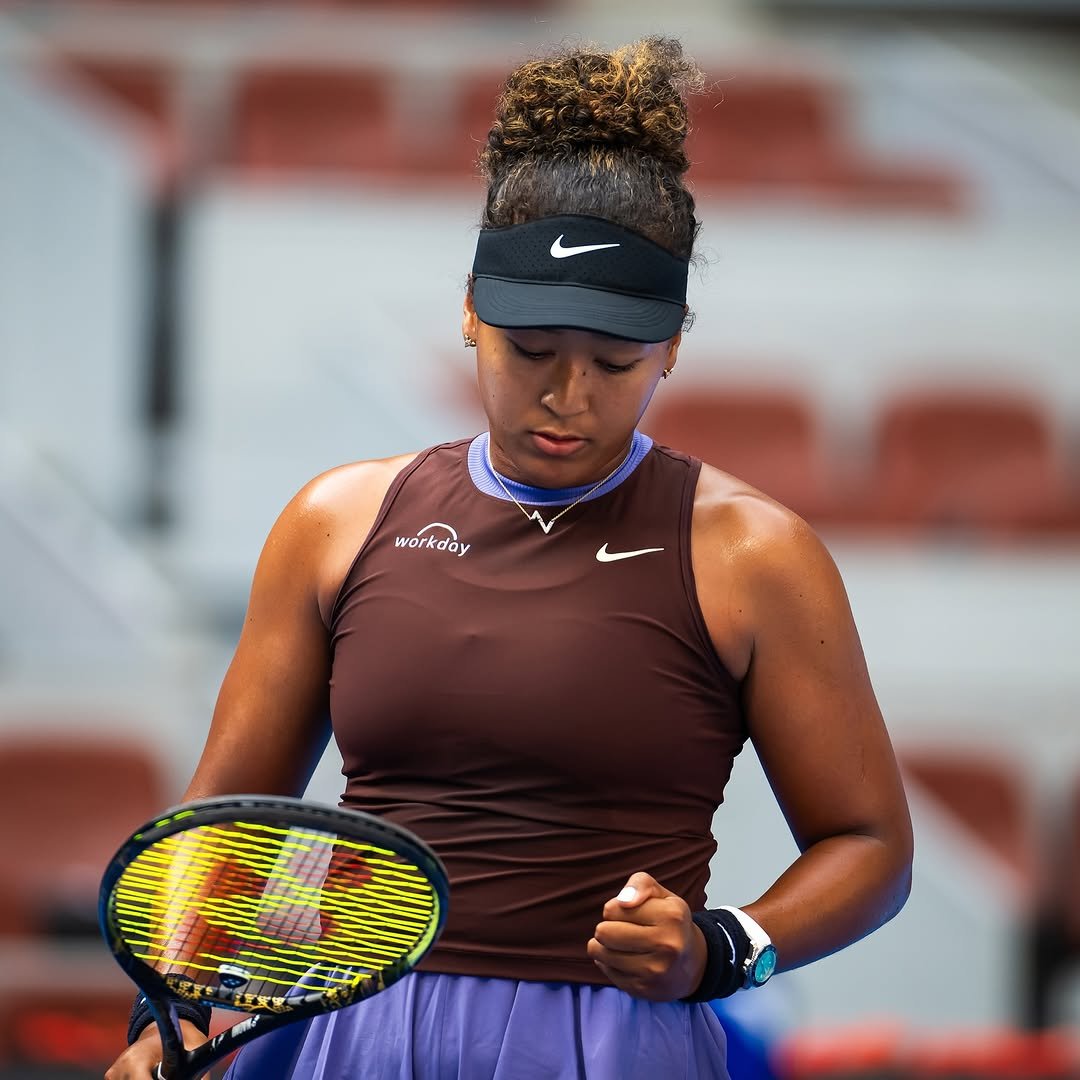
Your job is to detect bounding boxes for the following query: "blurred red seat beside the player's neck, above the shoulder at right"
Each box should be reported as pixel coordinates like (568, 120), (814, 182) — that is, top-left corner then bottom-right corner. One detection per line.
(642, 384), (832, 521)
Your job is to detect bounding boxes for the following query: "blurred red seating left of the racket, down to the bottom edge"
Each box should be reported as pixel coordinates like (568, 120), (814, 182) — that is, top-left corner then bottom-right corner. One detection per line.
(0, 730), (176, 1080)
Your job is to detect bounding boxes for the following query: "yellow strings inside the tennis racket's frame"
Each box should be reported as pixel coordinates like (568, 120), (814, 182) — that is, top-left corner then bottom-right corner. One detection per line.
(112, 822), (438, 997)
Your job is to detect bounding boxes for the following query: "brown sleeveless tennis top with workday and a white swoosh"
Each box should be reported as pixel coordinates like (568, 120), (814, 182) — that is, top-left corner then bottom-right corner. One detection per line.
(330, 440), (745, 984)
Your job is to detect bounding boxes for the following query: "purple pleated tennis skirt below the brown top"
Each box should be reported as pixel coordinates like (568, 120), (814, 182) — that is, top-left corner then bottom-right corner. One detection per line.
(225, 972), (728, 1080)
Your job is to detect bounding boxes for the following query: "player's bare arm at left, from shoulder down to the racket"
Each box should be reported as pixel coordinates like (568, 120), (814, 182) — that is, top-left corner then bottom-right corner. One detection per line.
(186, 462), (408, 798)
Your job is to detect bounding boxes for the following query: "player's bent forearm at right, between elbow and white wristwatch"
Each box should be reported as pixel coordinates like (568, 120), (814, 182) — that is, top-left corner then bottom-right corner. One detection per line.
(742, 833), (912, 970)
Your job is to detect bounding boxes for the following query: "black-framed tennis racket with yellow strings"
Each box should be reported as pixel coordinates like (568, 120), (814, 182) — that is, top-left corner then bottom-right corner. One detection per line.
(98, 795), (448, 1080)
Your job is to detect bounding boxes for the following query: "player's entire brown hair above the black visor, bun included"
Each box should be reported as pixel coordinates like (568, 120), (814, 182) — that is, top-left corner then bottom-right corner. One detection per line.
(481, 38), (704, 259)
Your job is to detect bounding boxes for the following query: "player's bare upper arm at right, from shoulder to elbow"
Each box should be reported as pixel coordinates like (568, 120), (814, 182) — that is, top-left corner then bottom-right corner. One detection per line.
(696, 497), (912, 858)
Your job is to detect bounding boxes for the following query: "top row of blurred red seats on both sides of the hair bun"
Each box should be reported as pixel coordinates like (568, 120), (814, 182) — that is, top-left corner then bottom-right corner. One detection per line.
(46, 35), (968, 204)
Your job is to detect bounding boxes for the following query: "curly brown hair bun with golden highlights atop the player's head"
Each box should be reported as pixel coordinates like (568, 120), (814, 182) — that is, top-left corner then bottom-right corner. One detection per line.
(481, 38), (704, 177)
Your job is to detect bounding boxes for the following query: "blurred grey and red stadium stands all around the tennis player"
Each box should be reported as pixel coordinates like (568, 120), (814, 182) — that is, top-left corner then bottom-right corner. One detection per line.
(0, 0), (1080, 1080)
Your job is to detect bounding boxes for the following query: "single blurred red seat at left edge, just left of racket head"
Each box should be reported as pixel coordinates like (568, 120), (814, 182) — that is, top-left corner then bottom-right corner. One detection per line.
(0, 725), (175, 935)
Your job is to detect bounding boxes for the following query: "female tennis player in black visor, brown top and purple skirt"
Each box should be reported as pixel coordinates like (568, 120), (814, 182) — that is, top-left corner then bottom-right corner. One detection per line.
(107, 39), (912, 1080)
